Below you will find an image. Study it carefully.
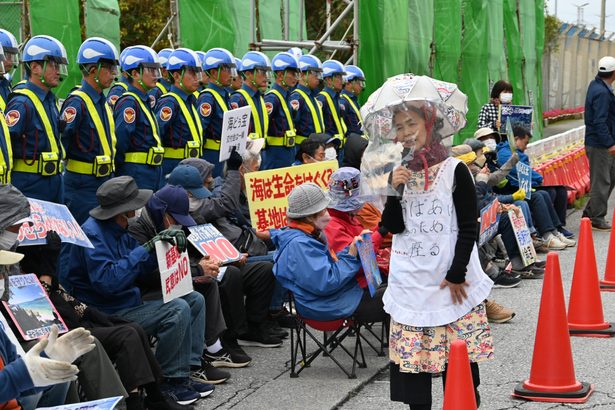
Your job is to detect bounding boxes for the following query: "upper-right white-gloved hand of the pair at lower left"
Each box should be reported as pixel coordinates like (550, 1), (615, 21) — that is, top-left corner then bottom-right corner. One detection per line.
(45, 325), (96, 363)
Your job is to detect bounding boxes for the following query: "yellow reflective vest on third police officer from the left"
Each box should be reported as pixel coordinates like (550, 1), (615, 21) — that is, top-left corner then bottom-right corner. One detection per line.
(66, 90), (116, 177)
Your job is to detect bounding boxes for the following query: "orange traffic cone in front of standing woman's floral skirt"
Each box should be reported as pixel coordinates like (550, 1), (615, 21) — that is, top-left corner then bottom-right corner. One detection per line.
(442, 340), (477, 410)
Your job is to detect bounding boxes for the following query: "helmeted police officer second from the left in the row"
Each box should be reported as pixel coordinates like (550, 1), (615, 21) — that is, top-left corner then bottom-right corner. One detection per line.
(6, 36), (68, 203)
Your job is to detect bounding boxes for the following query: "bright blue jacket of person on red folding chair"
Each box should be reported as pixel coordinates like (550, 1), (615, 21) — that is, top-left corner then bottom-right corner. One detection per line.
(271, 228), (363, 320)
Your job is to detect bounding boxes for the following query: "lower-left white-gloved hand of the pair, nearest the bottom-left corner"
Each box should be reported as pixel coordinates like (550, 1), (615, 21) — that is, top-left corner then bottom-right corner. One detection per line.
(23, 339), (79, 387)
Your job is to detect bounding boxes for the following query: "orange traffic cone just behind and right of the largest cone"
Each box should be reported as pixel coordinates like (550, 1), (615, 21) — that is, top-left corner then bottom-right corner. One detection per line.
(568, 218), (615, 337)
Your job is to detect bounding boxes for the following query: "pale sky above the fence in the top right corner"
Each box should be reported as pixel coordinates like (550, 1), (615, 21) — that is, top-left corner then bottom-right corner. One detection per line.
(546, 0), (615, 31)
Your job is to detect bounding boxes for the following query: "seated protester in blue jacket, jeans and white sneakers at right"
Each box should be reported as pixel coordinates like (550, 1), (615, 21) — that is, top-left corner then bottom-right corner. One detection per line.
(497, 127), (576, 250)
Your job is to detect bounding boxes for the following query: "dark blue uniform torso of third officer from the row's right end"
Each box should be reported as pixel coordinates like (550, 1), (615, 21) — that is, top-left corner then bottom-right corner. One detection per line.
(289, 84), (324, 144)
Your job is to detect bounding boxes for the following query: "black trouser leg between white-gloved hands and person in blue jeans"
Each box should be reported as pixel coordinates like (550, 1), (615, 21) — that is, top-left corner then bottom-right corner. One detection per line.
(89, 323), (162, 392)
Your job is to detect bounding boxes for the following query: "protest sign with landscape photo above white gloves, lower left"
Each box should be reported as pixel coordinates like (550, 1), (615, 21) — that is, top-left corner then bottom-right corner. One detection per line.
(2, 273), (68, 340)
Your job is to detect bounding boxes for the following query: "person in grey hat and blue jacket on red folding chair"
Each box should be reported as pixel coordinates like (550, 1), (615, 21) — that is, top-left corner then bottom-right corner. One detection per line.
(271, 182), (386, 322)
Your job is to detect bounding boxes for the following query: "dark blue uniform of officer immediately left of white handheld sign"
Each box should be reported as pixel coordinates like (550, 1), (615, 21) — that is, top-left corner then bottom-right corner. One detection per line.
(196, 82), (230, 178)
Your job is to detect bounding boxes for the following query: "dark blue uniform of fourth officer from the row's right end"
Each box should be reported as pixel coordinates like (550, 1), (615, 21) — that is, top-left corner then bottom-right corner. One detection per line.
(261, 83), (296, 169)
